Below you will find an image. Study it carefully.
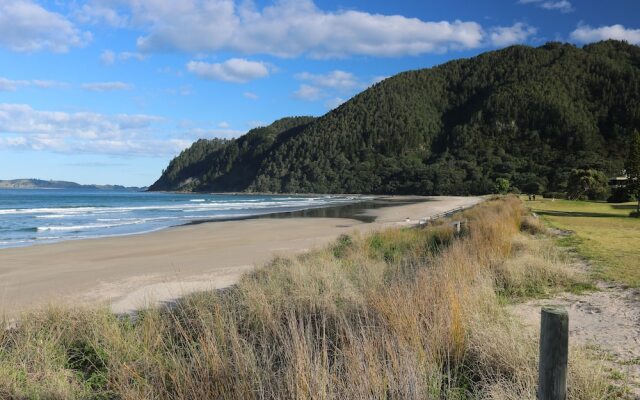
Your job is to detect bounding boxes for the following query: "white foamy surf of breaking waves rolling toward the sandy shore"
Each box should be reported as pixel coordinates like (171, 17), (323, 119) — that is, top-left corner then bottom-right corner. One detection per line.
(0, 196), (365, 247)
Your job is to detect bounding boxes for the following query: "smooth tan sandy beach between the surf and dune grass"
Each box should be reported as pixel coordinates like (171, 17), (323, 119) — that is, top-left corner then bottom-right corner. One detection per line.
(0, 197), (481, 316)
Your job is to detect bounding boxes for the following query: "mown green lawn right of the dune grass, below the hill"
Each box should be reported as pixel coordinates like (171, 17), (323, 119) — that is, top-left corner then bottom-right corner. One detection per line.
(525, 199), (640, 287)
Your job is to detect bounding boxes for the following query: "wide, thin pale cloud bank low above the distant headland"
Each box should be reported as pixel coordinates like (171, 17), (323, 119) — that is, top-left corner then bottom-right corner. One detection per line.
(0, 104), (192, 156)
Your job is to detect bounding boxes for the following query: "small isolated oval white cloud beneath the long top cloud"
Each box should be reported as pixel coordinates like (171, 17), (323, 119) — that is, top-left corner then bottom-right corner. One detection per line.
(187, 58), (269, 83)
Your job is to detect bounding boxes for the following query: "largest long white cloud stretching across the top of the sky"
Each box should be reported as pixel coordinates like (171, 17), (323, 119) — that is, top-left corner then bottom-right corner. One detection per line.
(77, 0), (484, 58)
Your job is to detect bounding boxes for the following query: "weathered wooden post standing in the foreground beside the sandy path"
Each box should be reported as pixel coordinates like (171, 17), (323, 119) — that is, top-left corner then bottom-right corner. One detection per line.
(538, 307), (569, 400)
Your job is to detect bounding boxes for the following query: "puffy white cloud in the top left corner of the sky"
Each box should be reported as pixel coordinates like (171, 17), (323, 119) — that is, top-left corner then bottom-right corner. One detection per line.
(0, 0), (91, 52)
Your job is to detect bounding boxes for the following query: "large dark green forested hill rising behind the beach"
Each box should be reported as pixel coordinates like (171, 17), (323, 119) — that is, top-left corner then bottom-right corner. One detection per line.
(151, 41), (640, 194)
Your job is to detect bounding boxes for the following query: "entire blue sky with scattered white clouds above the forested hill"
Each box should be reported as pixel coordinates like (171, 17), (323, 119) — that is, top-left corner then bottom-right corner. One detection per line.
(0, 0), (640, 186)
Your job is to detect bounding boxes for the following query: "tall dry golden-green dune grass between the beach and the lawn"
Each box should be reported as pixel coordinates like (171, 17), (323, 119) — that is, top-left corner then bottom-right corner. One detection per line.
(0, 198), (610, 399)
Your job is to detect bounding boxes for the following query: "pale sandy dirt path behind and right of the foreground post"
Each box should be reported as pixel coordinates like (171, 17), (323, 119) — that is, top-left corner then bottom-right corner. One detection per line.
(512, 283), (640, 399)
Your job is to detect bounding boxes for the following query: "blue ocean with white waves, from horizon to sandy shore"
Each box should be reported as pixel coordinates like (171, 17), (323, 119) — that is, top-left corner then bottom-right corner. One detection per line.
(0, 189), (362, 248)
